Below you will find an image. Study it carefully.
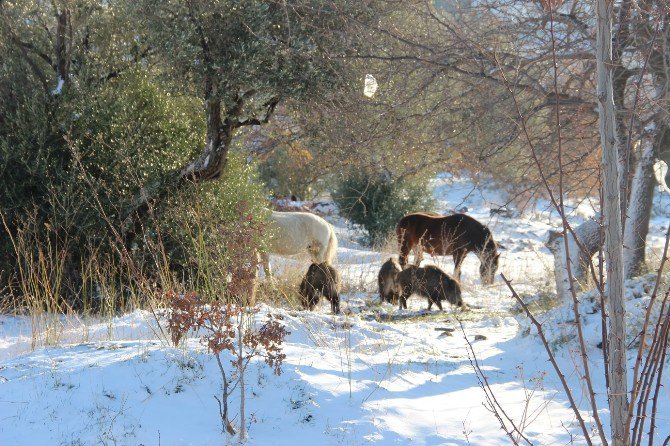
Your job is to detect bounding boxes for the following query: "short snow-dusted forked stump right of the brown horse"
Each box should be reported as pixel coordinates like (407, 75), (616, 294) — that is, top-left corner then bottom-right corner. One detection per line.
(546, 216), (600, 302)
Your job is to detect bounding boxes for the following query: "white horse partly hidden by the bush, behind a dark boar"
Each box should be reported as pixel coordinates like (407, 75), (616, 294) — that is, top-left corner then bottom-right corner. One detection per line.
(262, 211), (337, 277)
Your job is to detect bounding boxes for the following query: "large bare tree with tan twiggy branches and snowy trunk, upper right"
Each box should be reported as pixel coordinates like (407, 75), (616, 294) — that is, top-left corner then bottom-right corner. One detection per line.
(338, 0), (670, 300)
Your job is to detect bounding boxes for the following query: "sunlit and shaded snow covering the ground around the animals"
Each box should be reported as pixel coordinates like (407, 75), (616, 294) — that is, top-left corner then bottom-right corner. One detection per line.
(0, 175), (670, 446)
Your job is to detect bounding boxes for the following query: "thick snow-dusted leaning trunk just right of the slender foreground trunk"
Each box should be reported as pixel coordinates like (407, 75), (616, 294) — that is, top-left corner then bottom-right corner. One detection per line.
(623, 140), (656, 279)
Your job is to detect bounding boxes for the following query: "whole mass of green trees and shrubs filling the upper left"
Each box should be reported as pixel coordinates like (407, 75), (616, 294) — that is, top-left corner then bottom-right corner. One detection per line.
(0, 0), (372, 310)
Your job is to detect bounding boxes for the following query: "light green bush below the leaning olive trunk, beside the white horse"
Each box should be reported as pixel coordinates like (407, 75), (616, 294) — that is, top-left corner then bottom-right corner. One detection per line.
(158, 153), (268, 299)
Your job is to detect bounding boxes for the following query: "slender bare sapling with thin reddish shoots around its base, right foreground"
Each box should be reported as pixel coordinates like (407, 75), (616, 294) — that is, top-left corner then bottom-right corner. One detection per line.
(476, 0), (670, 445)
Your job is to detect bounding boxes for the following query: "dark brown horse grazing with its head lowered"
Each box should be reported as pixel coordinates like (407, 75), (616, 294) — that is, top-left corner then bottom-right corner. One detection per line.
(396, 212), (500, 285)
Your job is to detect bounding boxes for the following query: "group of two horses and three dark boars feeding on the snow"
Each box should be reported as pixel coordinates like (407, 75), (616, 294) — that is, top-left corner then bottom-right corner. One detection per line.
(263, 211), (500, 314)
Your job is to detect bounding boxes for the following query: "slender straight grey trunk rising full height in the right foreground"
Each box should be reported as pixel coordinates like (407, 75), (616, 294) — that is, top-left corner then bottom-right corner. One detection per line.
(596, 0), (629, 446)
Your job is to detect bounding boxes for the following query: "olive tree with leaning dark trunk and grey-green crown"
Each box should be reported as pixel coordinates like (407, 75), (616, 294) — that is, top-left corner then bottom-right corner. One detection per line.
(123, 0), (378, 244)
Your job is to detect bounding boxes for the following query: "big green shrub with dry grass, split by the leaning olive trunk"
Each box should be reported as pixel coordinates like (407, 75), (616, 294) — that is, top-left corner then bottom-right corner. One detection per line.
(0, 71), (272, 311)
